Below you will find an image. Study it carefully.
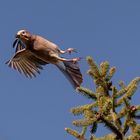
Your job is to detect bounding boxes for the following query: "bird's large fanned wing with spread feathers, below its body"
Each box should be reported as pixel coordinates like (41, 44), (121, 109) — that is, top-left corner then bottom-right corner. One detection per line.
(6, 49), (47, 78)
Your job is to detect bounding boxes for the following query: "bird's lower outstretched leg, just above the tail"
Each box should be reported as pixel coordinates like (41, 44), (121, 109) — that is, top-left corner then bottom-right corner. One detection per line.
(51, 54), (81, 63)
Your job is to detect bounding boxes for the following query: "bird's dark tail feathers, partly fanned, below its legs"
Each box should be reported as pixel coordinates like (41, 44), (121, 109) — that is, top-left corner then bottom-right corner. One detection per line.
(56, 62), (83, 89)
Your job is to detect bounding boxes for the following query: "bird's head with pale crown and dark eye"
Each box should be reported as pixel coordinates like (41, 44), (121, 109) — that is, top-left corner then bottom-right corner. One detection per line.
(15, 30), (31, 42)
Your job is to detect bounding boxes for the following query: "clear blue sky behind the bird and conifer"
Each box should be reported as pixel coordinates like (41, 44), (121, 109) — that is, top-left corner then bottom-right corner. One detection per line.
(0, 0), (140, 140)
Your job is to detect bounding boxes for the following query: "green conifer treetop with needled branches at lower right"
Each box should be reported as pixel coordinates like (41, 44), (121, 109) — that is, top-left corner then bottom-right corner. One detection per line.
(65, 57), (140, 140)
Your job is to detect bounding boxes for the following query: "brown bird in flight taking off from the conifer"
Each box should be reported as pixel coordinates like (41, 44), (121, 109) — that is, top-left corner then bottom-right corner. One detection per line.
(6, 30), (83, 89)
